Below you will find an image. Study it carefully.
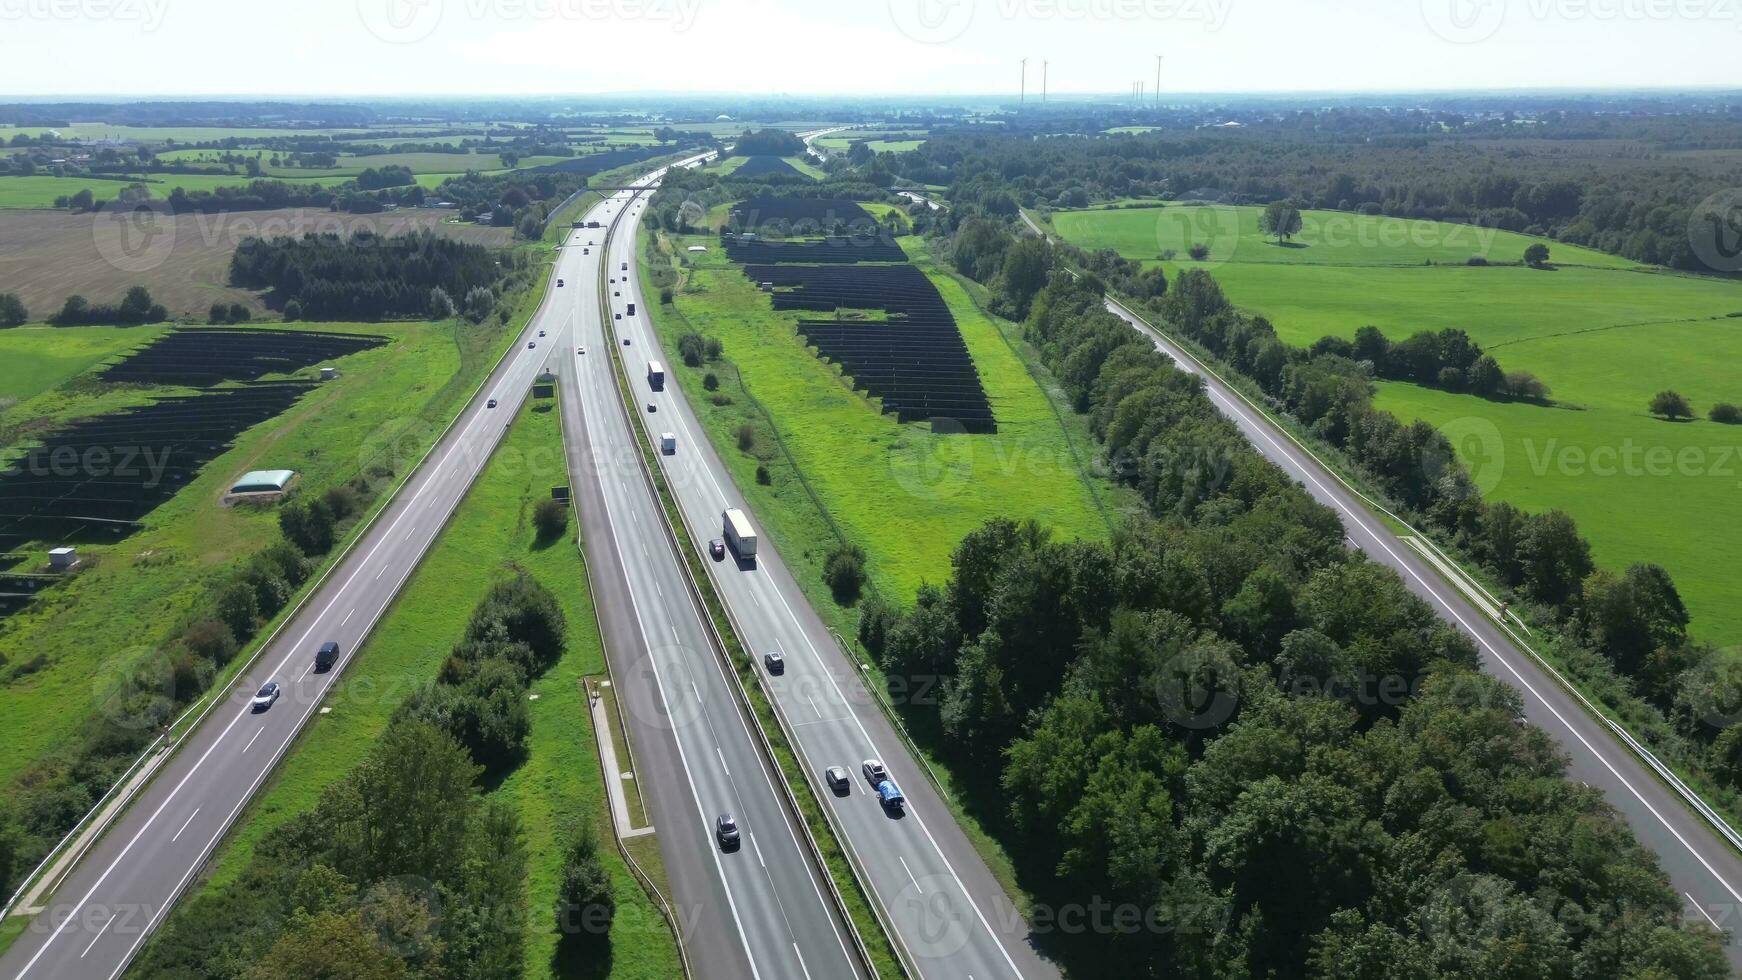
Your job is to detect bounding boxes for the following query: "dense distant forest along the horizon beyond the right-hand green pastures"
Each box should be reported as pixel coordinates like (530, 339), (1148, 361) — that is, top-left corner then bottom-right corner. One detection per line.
(880, 111), (1742, 270)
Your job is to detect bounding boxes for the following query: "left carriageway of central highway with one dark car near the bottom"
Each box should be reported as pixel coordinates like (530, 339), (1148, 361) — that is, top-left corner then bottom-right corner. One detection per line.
(549, 162), (862, 978)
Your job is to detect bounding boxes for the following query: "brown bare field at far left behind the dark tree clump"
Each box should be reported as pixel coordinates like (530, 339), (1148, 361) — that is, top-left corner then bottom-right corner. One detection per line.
(0, 207), (512, 320)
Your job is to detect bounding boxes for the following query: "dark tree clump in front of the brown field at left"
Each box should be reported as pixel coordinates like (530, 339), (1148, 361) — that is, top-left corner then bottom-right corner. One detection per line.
(230, 228), (526, 320)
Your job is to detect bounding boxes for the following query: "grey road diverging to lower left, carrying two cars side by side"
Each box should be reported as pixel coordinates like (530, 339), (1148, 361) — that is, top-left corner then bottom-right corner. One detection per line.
(0, 203), (578, 980)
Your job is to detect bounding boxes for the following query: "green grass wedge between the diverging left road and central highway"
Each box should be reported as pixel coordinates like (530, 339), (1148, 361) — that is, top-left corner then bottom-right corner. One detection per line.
(168, 402), (678, 980)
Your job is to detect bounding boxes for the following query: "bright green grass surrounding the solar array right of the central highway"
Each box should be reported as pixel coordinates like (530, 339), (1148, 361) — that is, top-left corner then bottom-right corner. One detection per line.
(653, 228), (1110, 611)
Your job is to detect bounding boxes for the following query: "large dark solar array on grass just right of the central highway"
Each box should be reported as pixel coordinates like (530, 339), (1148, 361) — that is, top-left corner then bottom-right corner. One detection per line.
(744, 265), (998, 433)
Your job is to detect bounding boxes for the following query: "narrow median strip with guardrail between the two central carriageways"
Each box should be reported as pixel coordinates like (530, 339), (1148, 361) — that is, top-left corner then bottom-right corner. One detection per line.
(598, 187), (898, 977)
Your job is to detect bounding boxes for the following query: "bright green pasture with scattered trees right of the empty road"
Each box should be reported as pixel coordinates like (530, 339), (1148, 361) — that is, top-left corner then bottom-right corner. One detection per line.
(1052, 205), (1742, 646)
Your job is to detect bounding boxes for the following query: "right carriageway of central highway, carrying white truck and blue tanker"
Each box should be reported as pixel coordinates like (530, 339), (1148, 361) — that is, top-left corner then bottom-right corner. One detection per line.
(589, 167), (1057, 980)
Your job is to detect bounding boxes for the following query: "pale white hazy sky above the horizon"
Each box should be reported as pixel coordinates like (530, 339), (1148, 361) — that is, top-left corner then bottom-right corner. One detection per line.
(0, 0), (1742, 99)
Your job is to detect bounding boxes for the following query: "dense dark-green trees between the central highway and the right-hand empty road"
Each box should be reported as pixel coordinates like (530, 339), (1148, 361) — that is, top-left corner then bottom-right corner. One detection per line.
(861, 275), (1728, 978)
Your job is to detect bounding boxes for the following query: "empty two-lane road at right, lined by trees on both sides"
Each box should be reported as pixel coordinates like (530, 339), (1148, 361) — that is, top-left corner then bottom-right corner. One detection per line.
(1106, 301), (1742, 968)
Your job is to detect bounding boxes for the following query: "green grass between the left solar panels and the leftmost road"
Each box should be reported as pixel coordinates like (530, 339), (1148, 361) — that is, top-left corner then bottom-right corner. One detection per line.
(0, 322), (507, 785)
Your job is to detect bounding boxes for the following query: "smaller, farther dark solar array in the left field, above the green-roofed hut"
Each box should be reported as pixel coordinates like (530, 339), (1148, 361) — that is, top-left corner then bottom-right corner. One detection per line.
(101, 327), (387, 386)
